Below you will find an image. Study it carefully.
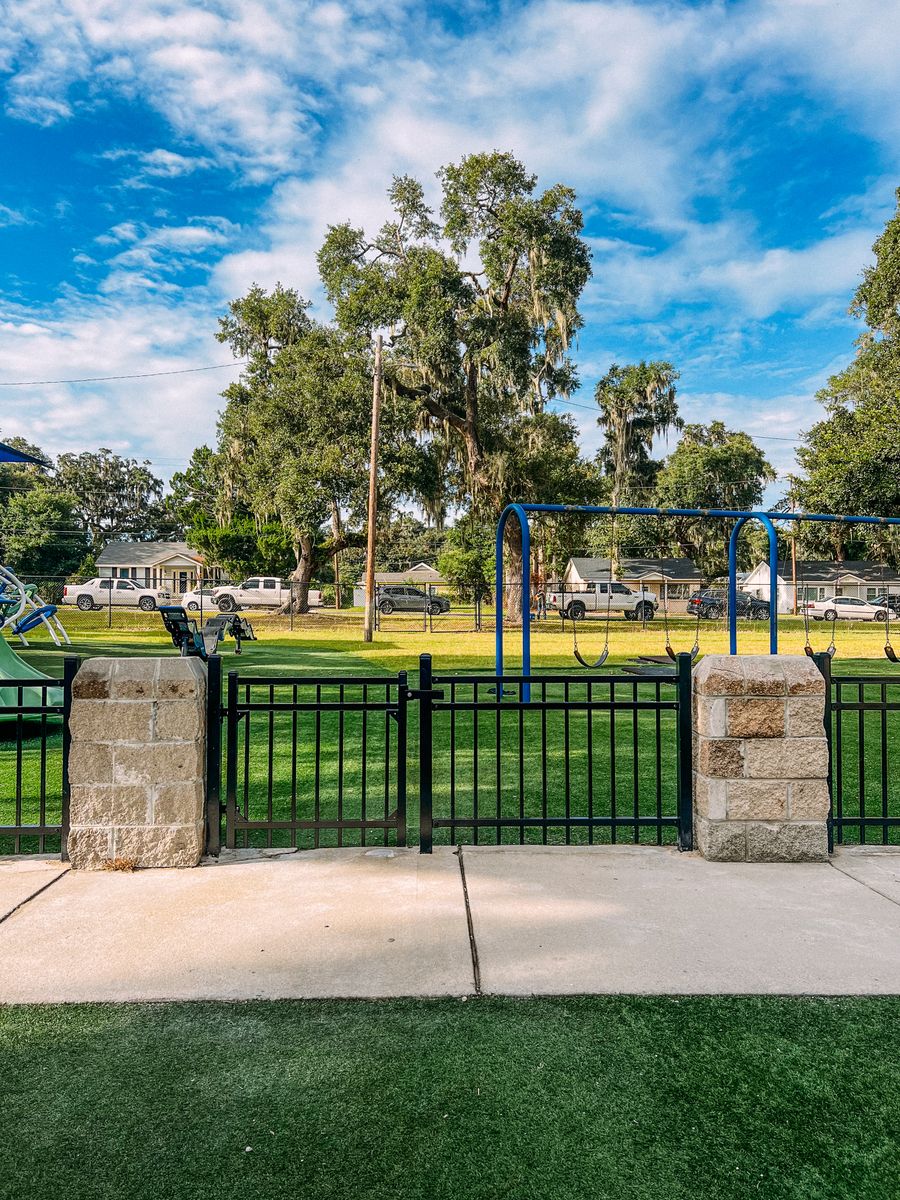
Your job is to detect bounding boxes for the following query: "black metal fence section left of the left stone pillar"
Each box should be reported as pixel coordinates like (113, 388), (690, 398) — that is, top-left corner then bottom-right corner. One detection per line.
(0, 658), (78, 858)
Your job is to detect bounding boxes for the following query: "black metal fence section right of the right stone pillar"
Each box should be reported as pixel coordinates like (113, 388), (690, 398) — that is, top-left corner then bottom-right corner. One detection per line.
(816, 654), (900, 848)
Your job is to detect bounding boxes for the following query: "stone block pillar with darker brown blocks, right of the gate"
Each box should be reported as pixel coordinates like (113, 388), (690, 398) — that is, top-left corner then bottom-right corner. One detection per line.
(694, 654), (829, 863)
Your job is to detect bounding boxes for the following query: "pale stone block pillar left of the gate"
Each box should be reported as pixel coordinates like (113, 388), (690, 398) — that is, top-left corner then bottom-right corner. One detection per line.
(68, 658), (206, 870)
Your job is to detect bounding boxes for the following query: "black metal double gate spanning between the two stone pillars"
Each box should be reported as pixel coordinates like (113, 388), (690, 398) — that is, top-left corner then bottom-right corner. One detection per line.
(208, 654), (691, 853)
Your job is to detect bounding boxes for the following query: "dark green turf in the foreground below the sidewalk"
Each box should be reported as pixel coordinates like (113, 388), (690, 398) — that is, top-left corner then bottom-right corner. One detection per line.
(0, 997), (900, 1200)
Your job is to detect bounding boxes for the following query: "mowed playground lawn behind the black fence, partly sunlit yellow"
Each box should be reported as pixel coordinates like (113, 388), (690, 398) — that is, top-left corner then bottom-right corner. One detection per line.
(0, 611), (900, 852)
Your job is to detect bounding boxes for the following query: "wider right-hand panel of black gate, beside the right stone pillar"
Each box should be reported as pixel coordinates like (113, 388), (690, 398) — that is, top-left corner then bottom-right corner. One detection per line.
(418, 654), (691, 853)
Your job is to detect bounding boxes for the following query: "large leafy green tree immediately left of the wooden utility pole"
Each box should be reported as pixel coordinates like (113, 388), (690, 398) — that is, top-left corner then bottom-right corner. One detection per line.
(217, 284), (374, 612)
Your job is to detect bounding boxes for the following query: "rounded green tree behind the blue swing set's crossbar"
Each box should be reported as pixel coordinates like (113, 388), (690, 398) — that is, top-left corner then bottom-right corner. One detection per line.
(654, 421), (775, 580)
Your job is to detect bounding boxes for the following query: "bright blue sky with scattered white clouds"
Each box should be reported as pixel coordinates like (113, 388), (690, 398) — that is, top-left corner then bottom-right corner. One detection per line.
(0, 0), (900, 499)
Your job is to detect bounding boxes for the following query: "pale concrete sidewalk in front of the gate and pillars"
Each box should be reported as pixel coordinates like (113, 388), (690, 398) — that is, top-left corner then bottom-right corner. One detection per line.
(0, 846), (900, 1003)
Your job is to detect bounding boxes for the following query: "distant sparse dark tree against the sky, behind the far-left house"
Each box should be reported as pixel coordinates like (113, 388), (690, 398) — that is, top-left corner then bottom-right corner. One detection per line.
(54, 448), (162, 552)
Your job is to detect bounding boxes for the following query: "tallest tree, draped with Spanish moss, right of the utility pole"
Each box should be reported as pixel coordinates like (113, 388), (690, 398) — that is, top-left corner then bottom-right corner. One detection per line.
(318, 151), (590, 619)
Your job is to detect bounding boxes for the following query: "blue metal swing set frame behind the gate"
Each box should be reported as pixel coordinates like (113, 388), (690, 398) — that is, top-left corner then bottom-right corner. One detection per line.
(494, 504), (900, 698)
